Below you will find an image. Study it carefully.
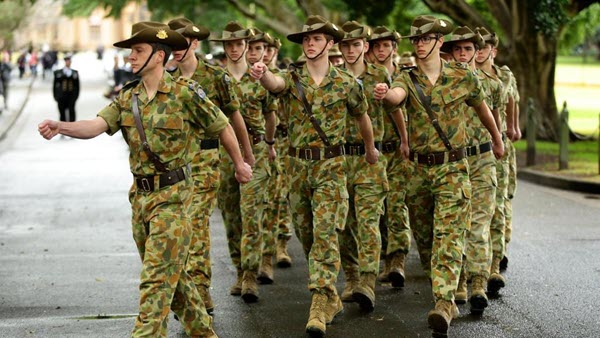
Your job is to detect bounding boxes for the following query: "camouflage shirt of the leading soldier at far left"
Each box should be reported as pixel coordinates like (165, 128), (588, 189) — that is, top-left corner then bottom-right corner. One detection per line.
(98, 72), (227, 176)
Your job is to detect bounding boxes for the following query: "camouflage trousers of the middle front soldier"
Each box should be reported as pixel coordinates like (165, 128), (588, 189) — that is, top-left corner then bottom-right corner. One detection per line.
(286, 156), (348, 294)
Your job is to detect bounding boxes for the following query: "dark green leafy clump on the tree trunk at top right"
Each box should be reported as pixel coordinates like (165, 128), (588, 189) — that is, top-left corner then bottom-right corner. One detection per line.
(527, 0), (569, 39)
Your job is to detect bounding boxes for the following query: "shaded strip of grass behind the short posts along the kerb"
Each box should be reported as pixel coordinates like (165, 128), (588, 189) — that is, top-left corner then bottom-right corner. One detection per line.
(515, 140), (600, 183)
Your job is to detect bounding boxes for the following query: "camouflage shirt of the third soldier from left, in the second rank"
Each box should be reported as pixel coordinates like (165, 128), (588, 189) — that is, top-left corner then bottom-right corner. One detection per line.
(231, 68), (277, 135)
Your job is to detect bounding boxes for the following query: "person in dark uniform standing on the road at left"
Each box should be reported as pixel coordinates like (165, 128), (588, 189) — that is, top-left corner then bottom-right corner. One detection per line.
(52, 55), (79, 122)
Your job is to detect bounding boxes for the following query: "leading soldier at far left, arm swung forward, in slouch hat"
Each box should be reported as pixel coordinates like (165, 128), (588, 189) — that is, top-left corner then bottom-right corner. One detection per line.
(38, 22), (252, 337)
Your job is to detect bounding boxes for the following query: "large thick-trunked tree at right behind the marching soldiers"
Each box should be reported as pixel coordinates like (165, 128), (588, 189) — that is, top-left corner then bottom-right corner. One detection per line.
(423, 0), (596, 140)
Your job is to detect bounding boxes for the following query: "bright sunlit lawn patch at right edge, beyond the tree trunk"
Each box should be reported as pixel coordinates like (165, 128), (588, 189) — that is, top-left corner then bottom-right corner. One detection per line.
(554, 56), (600, 137)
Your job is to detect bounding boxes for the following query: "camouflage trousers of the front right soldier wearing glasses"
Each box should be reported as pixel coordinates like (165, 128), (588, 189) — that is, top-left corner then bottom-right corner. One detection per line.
(406, 159), (471, 301)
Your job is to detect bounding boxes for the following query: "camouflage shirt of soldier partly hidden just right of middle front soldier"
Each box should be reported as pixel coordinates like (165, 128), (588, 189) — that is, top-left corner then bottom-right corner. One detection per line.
(346, 62), (392, 144)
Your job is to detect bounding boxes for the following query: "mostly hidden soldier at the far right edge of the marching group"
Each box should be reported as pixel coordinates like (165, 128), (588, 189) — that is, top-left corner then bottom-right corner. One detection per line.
(475, 28), (513, 295)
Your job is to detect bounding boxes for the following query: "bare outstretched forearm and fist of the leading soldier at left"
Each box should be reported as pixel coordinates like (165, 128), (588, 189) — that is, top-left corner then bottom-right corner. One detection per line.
(38, 117), (108, 140)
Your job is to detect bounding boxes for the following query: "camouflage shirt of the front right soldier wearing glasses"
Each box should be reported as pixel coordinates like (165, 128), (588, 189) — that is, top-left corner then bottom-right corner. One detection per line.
(392, 62), (484, 153)
